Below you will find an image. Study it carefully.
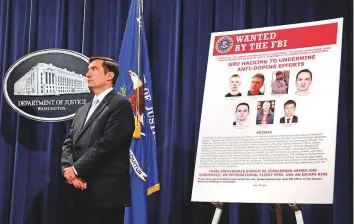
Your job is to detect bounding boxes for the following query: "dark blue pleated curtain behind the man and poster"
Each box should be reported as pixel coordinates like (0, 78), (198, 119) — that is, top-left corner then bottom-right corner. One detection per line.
(0, 0), (353, 224)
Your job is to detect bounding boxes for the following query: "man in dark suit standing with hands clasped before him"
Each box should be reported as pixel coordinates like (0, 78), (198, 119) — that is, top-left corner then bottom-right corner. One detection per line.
(61, 57), (134, 224)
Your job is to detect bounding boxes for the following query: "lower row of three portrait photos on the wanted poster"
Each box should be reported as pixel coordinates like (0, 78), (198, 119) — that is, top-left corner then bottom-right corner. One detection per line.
(233, 99), (299, 126)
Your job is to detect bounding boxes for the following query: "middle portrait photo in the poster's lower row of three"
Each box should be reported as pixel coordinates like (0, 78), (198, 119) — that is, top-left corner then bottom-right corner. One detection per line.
(256, 100), (275, 125)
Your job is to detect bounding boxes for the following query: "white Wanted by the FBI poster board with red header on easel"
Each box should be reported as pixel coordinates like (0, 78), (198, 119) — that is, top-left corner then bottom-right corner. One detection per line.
(192, 18), (343, 204)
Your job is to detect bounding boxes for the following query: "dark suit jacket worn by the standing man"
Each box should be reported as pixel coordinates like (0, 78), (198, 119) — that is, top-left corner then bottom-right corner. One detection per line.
(61, 90), (134, 207)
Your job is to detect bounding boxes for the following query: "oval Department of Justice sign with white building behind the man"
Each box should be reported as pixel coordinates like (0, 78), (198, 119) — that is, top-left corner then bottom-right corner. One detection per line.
(3, 49), (93, 122)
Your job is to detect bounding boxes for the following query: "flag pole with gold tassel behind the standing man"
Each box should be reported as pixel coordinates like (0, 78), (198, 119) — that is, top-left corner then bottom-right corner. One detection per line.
(133, 0), (143, 139)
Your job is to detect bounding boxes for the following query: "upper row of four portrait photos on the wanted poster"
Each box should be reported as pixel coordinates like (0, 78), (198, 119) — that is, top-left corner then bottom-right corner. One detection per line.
(225, 69), (312, 97)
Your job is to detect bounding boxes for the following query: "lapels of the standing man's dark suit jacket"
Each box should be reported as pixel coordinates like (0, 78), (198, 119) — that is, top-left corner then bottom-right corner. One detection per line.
(76, 90), (114, 143)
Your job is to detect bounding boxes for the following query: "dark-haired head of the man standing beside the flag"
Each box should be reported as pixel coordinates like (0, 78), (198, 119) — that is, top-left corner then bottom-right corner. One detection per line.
(86, 57), (119, 94)
